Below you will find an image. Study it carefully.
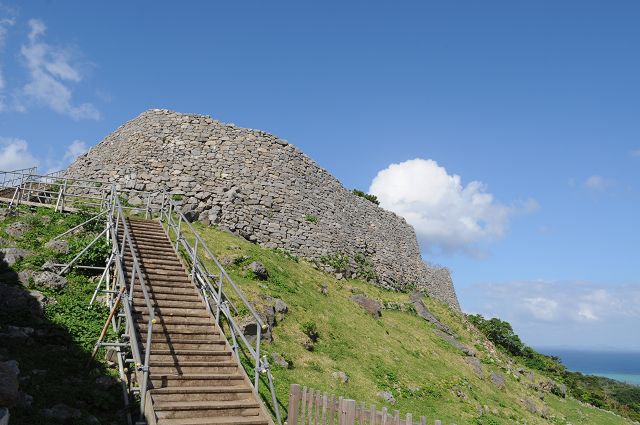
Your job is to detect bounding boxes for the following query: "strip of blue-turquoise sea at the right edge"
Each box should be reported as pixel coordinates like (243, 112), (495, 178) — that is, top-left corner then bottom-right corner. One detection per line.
(538, 348), (640, 386)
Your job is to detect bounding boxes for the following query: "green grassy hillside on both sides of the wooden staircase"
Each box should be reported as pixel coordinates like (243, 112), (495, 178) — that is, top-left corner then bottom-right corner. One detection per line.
(0, 205), (631, 425)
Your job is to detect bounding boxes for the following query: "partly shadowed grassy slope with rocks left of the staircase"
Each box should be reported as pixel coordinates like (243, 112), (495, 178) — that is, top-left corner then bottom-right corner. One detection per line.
(0, 208), (123, 425)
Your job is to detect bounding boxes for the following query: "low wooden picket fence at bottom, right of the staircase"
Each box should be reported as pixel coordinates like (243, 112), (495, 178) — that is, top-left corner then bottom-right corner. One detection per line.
(286, 384), (455, 425)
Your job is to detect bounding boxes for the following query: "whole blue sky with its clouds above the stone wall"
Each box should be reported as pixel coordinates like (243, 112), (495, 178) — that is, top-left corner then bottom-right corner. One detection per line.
(0, 0), (640, 350)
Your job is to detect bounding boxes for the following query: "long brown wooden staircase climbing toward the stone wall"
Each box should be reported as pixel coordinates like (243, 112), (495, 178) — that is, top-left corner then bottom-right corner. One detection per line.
(119, 219), (273, 425)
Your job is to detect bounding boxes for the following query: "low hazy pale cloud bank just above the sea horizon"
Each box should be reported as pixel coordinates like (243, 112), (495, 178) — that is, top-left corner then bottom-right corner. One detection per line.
(458, 280), (640, 350)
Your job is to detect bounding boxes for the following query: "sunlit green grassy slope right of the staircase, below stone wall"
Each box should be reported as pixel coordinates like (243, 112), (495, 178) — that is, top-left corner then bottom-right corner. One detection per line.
(191, 222), (631, 425)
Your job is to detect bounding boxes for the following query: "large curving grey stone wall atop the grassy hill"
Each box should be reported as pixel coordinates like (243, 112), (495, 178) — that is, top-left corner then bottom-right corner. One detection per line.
(67, 110), (459, 309)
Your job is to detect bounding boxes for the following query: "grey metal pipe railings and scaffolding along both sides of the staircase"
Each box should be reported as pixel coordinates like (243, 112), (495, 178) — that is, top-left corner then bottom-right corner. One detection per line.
(0, 169), (282, 424)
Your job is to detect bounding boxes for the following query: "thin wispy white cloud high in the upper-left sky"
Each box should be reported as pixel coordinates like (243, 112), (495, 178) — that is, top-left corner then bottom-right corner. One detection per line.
(17, 19), (100, 120)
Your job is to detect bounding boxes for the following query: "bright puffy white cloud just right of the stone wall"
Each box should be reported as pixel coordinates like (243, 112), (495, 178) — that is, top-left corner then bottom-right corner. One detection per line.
(369, 158), (537, 253)
